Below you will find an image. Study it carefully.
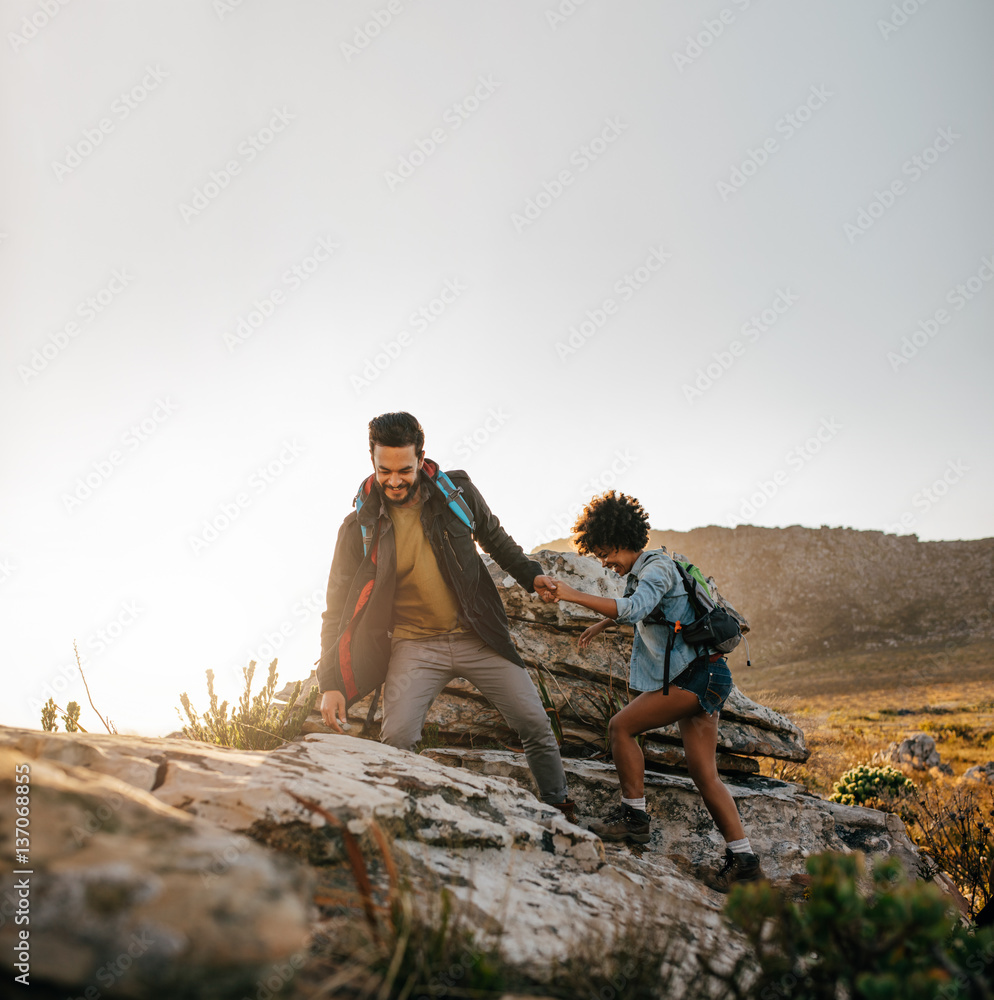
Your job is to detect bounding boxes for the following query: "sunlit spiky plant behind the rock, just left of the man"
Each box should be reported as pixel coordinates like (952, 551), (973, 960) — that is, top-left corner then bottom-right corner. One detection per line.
(176, 660), (318, 750)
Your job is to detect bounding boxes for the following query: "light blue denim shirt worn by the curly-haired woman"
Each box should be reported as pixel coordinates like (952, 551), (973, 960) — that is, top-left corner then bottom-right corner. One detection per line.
(614, 549), (697, 691)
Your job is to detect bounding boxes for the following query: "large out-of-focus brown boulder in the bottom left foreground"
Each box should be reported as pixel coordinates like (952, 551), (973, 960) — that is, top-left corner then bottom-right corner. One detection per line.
(0, 748), (312, 997)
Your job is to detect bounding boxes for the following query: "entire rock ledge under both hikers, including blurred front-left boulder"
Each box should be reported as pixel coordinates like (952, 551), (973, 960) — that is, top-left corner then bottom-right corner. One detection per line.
(0, 729), (915, 997)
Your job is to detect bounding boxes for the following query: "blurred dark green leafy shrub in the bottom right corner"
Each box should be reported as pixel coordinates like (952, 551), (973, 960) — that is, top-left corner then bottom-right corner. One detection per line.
(725, 853), (994, 1000)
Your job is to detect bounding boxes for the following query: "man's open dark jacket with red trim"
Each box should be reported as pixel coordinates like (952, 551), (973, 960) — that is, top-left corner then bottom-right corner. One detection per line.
(317, 471), (542, 704)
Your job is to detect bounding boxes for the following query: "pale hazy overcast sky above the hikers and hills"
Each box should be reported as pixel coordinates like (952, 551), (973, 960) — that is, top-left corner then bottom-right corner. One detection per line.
(0, 0), (994, 734)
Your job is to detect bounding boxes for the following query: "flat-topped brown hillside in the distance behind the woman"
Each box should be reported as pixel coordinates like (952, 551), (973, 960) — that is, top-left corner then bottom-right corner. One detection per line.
(537, 525), (994, 666)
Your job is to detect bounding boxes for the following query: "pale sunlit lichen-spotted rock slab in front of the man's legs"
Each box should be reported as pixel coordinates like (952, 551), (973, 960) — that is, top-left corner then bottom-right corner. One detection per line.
(0, 729), (600, 863)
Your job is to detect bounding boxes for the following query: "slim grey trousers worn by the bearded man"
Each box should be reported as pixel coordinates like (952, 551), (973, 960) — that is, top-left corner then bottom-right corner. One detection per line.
(380, 632), (567, 802)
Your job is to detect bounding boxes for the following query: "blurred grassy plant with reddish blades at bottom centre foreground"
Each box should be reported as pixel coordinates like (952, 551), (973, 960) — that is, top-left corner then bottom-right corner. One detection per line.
(286, 789), (716, 1000)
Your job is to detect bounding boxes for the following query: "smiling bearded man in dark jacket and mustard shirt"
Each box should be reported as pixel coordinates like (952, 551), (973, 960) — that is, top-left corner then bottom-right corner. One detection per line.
(318, 413), (574, 821)
